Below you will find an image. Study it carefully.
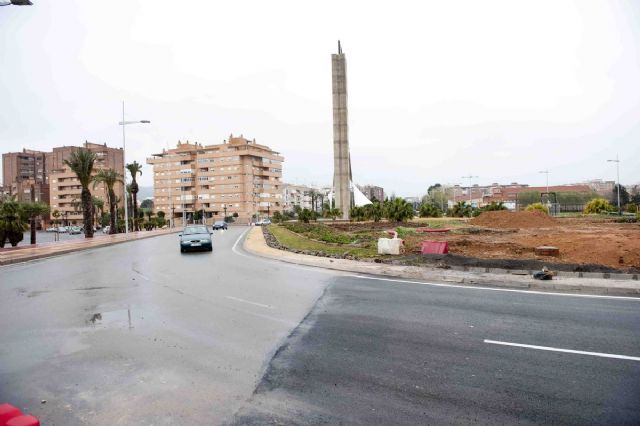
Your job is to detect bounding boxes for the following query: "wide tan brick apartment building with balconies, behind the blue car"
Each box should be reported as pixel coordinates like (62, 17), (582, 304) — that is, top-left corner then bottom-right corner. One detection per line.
(147, 135), (284, 225)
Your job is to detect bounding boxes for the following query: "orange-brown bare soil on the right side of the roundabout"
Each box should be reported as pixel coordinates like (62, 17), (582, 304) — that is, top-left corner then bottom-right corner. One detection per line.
(405, 216), (640, 273)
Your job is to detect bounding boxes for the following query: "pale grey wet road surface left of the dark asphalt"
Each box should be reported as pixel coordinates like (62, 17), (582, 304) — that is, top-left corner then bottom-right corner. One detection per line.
(0, 227), (333, 425)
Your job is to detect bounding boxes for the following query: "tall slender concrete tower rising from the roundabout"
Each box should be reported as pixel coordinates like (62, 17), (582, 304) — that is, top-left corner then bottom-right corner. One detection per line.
(331, 41), (352, 219)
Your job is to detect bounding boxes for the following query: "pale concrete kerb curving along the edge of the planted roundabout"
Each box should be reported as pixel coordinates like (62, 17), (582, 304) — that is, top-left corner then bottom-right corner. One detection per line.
(243, 227), (640, 297)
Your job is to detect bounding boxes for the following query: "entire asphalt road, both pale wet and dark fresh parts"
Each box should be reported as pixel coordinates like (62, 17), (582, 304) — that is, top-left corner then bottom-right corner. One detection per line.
(0, 228), (640, 425)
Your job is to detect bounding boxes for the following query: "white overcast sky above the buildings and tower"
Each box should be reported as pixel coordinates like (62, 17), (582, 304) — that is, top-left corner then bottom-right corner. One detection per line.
(0, 0), (640, 196)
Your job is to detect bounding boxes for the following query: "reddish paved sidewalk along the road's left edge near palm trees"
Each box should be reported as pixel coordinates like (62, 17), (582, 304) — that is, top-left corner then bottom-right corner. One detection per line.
(0, 228), (182, 266)
